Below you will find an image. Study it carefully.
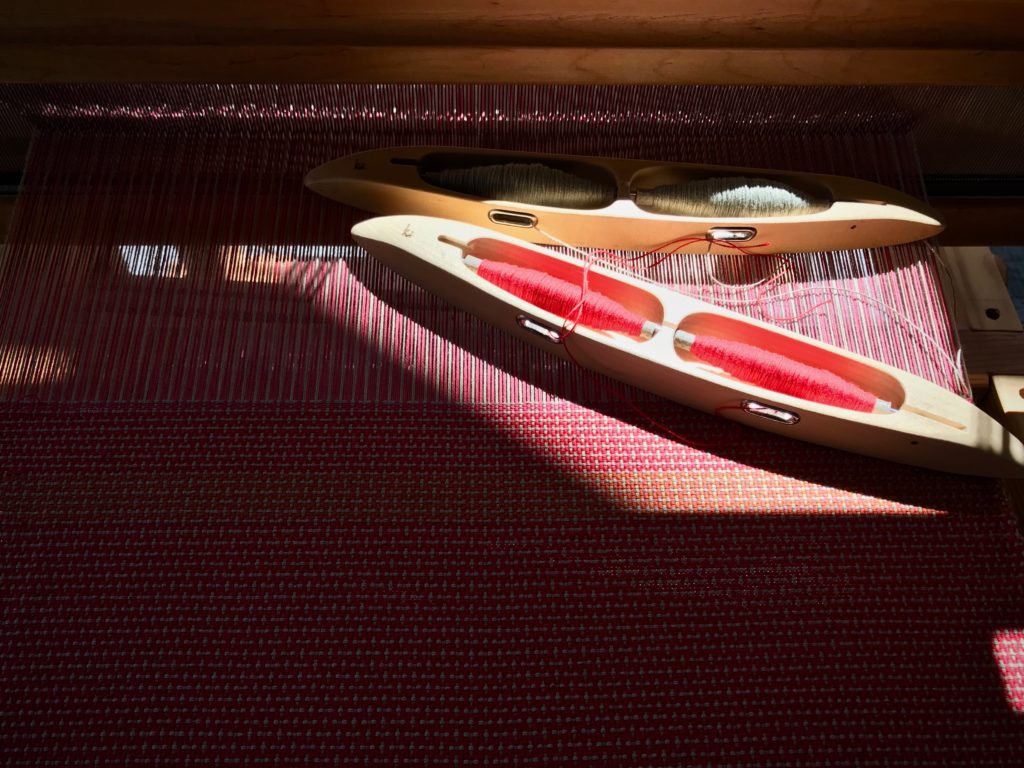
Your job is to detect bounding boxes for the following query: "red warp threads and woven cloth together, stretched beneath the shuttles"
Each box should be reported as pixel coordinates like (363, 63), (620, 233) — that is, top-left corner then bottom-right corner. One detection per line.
(0, 73), (1024, 766)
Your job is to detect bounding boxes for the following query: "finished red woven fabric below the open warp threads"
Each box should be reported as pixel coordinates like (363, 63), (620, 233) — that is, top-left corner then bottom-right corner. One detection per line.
(6, 404), (1024, 767)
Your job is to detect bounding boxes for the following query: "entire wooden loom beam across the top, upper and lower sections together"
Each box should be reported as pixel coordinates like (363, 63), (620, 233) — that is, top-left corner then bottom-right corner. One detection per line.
(0, 0), (1024, 85)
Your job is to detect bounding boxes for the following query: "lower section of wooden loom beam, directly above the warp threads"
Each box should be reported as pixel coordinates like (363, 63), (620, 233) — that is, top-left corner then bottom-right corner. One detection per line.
(0, 44), (1024, 86)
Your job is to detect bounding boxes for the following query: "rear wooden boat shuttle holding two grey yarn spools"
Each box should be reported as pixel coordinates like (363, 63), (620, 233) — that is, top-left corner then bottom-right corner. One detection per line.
(305, 146), (943, 253)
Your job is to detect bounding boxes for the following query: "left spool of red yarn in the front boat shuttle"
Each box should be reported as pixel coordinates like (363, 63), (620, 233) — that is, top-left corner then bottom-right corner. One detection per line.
(476, 260), (646, 336)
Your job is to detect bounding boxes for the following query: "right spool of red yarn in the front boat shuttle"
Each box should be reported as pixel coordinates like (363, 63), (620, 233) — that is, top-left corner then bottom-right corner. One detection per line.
(690, 336), (878, 412)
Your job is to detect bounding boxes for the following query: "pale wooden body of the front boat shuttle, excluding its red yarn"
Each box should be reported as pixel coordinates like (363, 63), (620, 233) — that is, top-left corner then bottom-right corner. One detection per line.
(352, 215), (1024, 477)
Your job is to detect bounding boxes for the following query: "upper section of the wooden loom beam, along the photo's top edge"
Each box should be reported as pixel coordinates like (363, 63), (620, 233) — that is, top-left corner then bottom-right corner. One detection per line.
(0, 0), (1024, 50)
